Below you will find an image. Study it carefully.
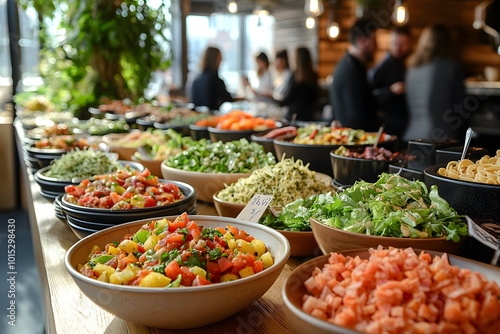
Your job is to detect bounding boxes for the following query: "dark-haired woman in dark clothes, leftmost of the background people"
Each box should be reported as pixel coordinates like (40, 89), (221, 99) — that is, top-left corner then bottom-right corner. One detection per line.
(189, 46), (241, 110)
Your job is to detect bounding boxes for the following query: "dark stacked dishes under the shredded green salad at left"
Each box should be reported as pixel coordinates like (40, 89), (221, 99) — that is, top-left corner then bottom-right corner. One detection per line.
(34, 160), (144, 200)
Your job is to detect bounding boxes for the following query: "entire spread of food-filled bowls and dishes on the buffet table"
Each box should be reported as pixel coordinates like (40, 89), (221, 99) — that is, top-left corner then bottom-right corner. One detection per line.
(14, 108), (500, 333)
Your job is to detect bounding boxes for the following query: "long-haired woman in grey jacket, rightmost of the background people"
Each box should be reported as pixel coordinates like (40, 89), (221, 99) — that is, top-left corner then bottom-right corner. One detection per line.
(403, 24), (465, 141)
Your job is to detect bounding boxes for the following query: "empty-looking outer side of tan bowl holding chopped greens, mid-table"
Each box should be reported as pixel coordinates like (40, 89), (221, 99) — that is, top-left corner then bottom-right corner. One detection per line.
(161, 163), (251, 203)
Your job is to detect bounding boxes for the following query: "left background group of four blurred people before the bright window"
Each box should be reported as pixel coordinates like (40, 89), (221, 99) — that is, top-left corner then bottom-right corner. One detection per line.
(189, 47), (319, 121)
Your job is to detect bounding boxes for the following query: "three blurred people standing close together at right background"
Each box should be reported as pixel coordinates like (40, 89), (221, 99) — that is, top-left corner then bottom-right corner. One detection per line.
(329, 19), (465, 142)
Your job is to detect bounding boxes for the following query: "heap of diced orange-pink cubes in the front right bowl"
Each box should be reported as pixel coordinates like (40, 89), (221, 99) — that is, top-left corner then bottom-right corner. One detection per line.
(302, 247), (500, 334)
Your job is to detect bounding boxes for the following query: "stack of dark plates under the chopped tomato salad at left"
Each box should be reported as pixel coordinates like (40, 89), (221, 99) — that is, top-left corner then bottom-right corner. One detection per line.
(54, 180), (198, 238)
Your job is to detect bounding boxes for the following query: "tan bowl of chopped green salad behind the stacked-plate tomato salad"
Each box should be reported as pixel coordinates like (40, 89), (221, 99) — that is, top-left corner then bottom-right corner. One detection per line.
(161, 139), (276, 203)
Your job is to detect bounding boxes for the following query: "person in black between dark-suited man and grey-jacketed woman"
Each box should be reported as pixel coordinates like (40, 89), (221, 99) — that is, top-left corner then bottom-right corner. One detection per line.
(368, 26), (413, 140)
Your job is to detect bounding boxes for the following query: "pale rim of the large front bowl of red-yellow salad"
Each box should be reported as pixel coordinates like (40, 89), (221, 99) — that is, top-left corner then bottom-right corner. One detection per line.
(64, 215), (291, 294)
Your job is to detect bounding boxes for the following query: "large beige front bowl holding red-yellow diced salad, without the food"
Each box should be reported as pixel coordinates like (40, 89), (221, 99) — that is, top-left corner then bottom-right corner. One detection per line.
(64, 215), (290, 329)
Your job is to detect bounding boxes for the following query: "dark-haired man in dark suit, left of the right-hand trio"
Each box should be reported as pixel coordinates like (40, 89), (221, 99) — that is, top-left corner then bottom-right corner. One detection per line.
(329, 18), (379, 131)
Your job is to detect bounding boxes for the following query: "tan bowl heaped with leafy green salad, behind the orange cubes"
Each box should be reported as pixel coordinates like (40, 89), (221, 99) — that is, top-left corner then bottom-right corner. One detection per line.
(310, 173), (468, 254)
